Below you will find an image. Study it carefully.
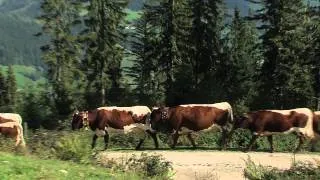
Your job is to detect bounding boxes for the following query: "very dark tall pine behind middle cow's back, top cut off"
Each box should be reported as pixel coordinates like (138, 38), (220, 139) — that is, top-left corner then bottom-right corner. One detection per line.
(185, 0), (224, 102)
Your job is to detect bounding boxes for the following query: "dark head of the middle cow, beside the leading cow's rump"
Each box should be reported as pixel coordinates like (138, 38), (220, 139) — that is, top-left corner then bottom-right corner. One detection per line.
(150, 107), (170, 132)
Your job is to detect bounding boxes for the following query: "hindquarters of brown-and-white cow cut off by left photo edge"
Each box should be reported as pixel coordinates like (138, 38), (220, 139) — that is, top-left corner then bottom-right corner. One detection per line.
(0, 115), (25, 147)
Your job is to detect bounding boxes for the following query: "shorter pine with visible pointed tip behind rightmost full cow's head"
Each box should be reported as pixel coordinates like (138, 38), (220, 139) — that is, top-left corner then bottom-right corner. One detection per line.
(223, 8), (262, 110)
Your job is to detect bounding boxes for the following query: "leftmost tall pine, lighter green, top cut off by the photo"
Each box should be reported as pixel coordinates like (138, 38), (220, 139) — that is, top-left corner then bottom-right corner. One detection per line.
(38, 0), (81, 116)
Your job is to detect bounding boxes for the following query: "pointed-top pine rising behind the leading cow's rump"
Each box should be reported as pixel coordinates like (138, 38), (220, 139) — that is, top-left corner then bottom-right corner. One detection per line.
(128, 3), (164, 106)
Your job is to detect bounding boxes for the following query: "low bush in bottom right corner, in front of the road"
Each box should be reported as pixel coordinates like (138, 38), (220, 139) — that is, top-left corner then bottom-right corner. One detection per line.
(244, 158), (320, 180)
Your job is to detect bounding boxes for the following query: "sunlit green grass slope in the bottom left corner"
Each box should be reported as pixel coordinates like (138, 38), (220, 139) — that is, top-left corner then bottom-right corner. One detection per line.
(0, 152), (127, 180)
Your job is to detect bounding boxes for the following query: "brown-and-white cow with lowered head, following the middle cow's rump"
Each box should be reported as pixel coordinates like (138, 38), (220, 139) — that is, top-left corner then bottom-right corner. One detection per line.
(229, 108), (319, 153)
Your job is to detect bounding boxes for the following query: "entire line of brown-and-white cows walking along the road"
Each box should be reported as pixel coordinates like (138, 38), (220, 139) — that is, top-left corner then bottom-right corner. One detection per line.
(0, 102), (320, 152)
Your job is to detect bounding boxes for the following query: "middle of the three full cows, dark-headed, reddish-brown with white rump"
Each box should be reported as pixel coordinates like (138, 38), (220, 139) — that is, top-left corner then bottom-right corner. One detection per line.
(150, 102), (233, 149)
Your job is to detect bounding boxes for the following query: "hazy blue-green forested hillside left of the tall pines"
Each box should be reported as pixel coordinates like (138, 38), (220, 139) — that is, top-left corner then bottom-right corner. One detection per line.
(0, 0), (43, 66)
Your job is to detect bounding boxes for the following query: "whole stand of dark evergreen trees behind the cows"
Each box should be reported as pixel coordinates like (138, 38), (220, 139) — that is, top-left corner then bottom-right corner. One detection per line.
(0, 0), (320, 128)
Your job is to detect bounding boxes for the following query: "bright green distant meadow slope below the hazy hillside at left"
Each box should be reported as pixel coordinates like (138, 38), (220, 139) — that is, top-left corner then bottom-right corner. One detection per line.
(0, 65), (45, 89)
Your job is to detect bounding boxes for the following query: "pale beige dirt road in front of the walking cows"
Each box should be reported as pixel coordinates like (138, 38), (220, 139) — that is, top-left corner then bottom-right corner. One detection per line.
(104, 151), (320, 180)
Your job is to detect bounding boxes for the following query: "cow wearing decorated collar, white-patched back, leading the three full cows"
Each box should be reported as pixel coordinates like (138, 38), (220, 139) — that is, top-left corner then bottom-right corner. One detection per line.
(71, 106), (159, 149)
